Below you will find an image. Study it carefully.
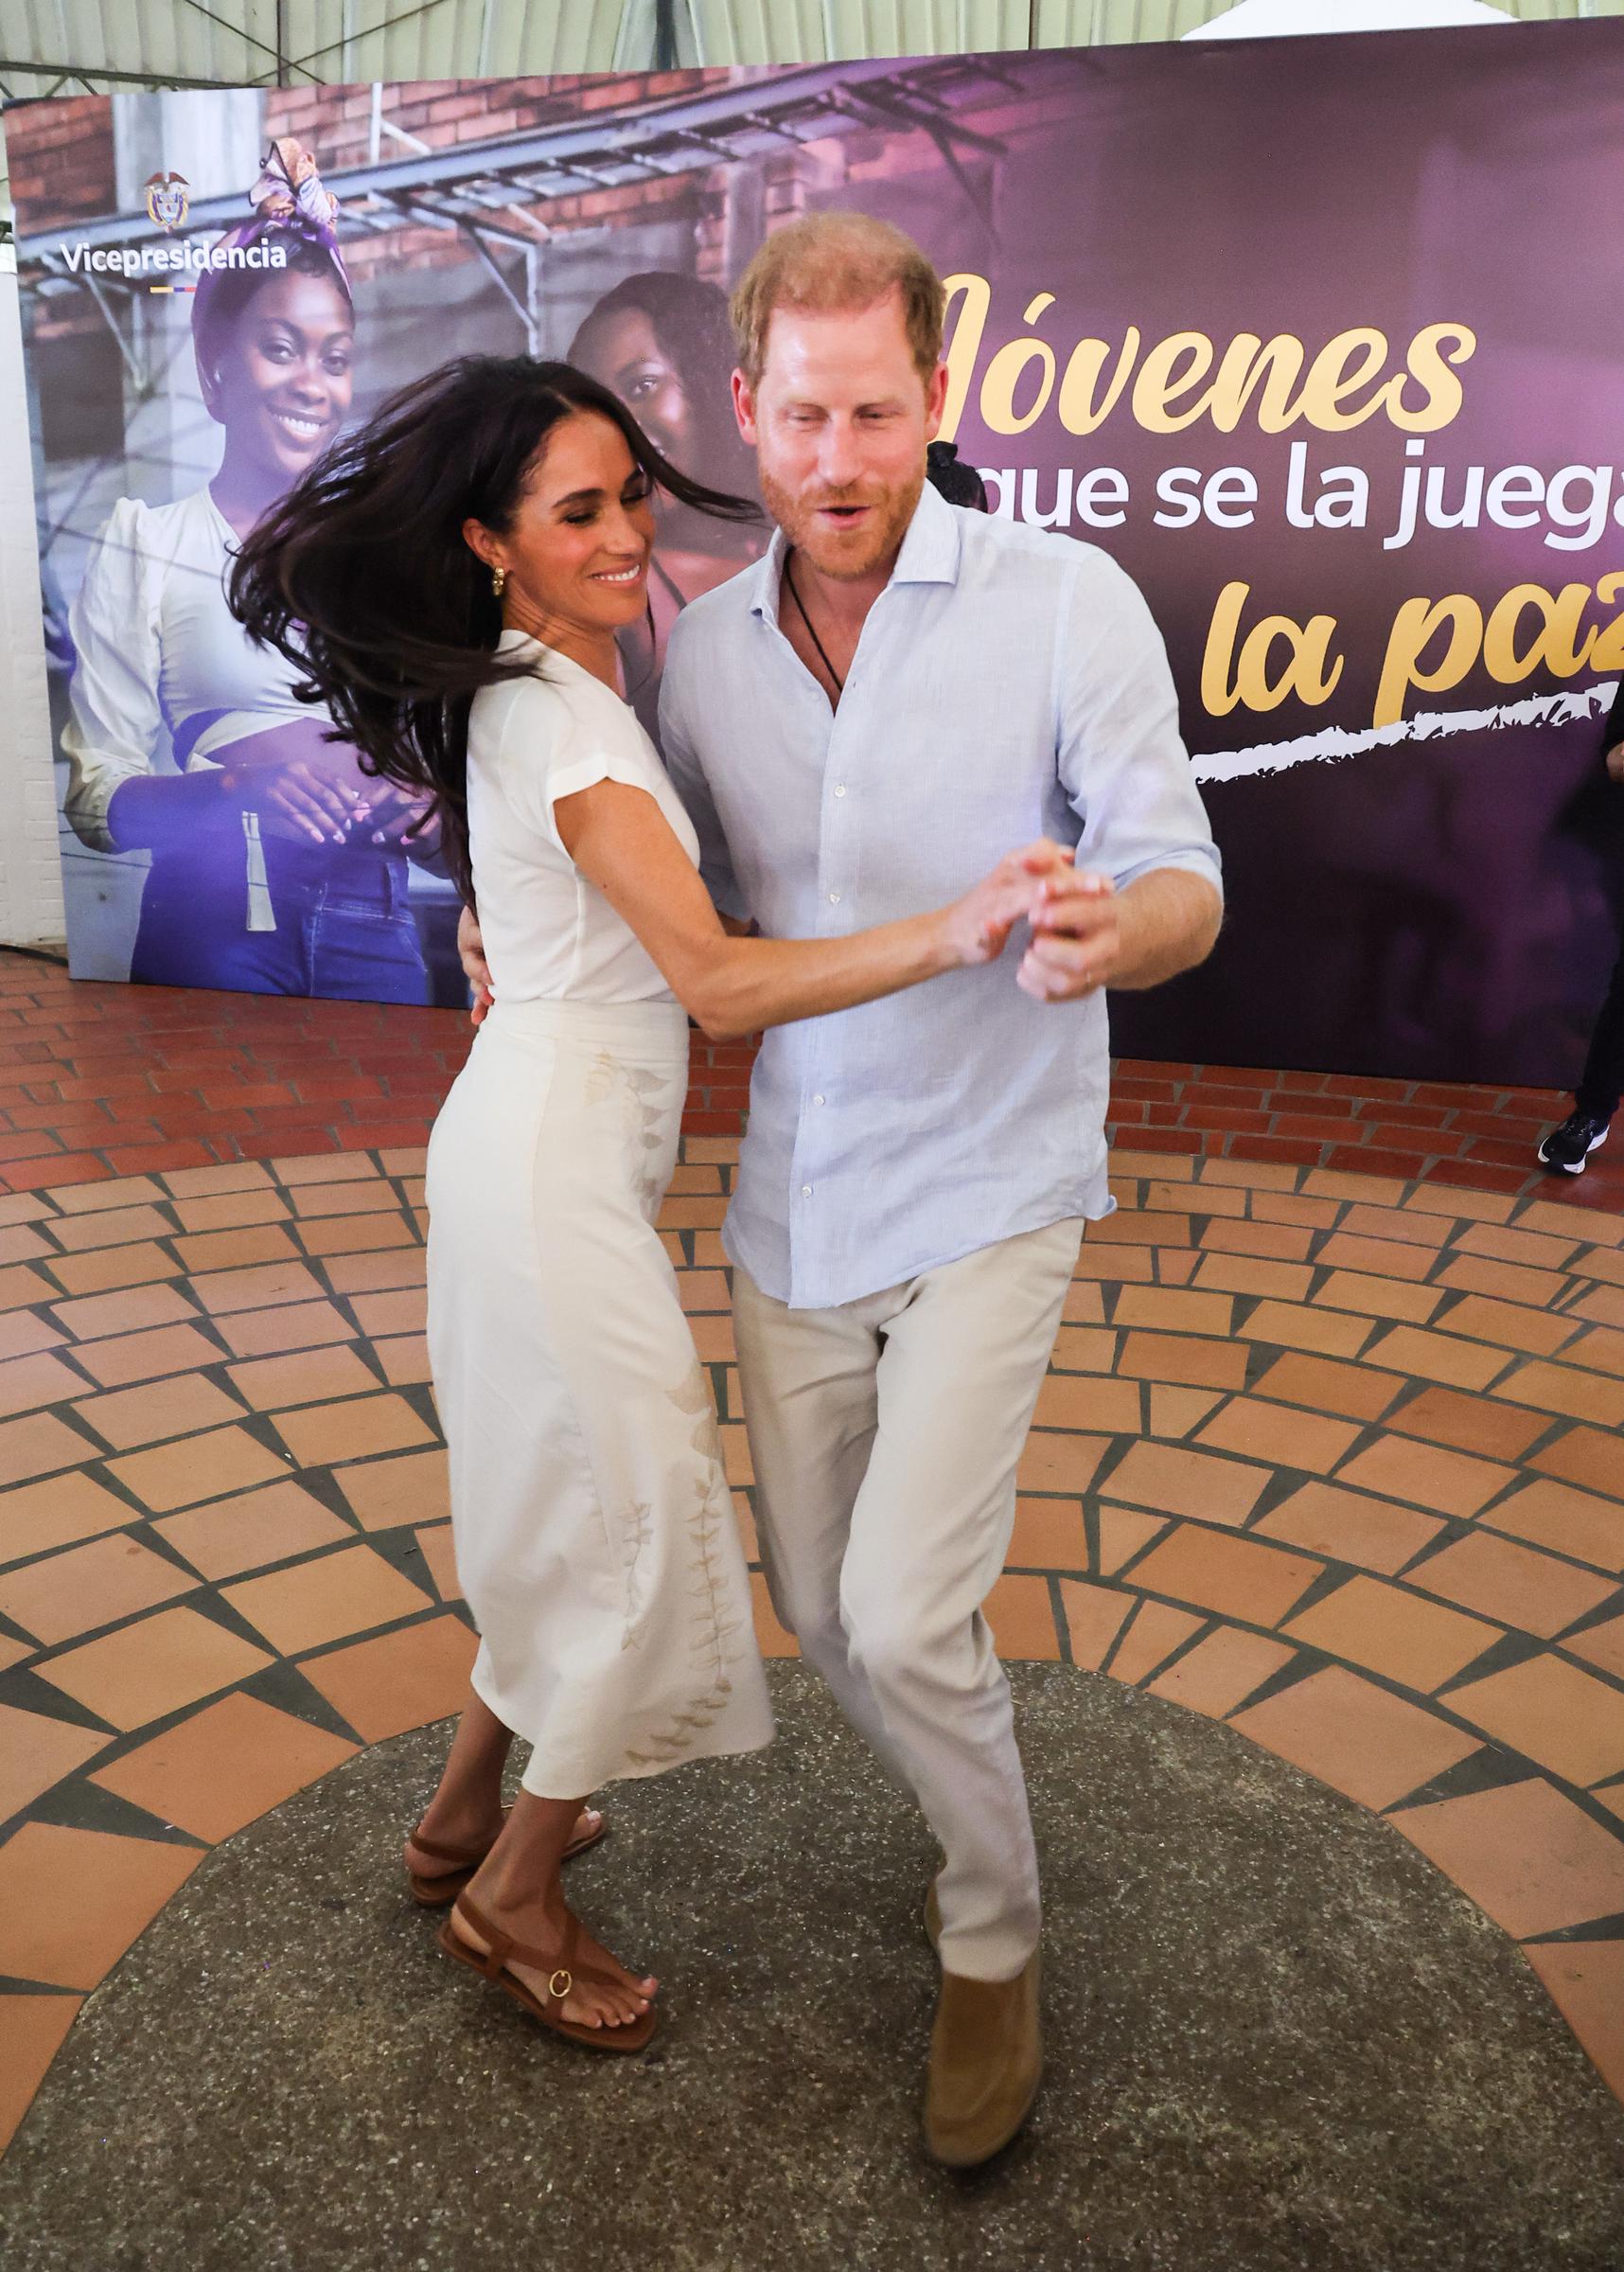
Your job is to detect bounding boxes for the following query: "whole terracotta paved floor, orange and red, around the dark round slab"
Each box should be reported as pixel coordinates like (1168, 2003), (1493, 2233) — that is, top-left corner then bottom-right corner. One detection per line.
(0, 956), (1624, 2138)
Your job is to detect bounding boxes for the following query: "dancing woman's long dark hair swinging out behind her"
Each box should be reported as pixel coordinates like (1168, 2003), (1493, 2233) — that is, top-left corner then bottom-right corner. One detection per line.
(227, 354), (759, 899)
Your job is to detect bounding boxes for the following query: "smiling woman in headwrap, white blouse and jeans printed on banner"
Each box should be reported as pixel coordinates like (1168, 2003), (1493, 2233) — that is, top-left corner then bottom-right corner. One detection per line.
(62, 138), (433, 1002)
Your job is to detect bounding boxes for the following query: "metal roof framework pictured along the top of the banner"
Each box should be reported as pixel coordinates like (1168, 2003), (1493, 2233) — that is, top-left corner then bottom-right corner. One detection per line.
(16, 52), (1043, 367)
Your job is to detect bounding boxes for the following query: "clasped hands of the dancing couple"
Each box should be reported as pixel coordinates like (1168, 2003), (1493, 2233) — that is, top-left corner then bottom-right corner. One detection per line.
(947, 836), (1122, 1002)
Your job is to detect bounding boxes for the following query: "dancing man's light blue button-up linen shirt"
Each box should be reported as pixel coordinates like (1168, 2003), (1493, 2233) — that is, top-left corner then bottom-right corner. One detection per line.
(659, 487), (1222, 1308)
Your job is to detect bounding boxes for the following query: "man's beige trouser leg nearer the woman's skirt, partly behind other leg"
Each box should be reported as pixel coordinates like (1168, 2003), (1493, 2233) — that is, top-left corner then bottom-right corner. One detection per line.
(733, 1266), (913, 1790)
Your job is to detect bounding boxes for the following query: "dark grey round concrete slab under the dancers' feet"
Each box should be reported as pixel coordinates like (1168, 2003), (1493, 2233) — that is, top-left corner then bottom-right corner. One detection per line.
(0, 1665), (1624, 2272)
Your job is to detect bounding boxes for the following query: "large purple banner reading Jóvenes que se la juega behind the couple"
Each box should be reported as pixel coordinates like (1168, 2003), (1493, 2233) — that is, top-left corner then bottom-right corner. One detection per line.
(7, 23), (1624, 1084)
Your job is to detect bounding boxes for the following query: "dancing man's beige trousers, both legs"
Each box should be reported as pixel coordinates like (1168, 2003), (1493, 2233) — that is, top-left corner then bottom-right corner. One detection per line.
(733, 1217), (1084, 1981)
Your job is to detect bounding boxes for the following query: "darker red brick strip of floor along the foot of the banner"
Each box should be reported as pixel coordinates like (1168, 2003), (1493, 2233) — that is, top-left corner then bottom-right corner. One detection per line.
(0, 950), (1624, 1208)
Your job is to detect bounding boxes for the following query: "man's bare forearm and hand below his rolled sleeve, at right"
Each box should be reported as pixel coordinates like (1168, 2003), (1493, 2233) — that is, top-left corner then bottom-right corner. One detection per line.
(1015, 868), (1225, 1002)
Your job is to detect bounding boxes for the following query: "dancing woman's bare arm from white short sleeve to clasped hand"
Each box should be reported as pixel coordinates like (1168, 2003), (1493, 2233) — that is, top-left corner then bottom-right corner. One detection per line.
(555, 782), (1068, 1040)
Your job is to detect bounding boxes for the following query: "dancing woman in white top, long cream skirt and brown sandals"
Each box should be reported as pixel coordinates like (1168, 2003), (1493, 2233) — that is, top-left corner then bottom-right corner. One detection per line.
(232, 357), (1058, 2051)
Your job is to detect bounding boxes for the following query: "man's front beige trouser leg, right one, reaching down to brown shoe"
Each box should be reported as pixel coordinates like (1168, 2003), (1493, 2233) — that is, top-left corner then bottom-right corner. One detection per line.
(840, 1220), (1081, 1981)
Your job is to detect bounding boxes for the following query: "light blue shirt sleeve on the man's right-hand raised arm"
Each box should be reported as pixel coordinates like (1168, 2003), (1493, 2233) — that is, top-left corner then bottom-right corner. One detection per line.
(1056, 547), (1225, 896)
